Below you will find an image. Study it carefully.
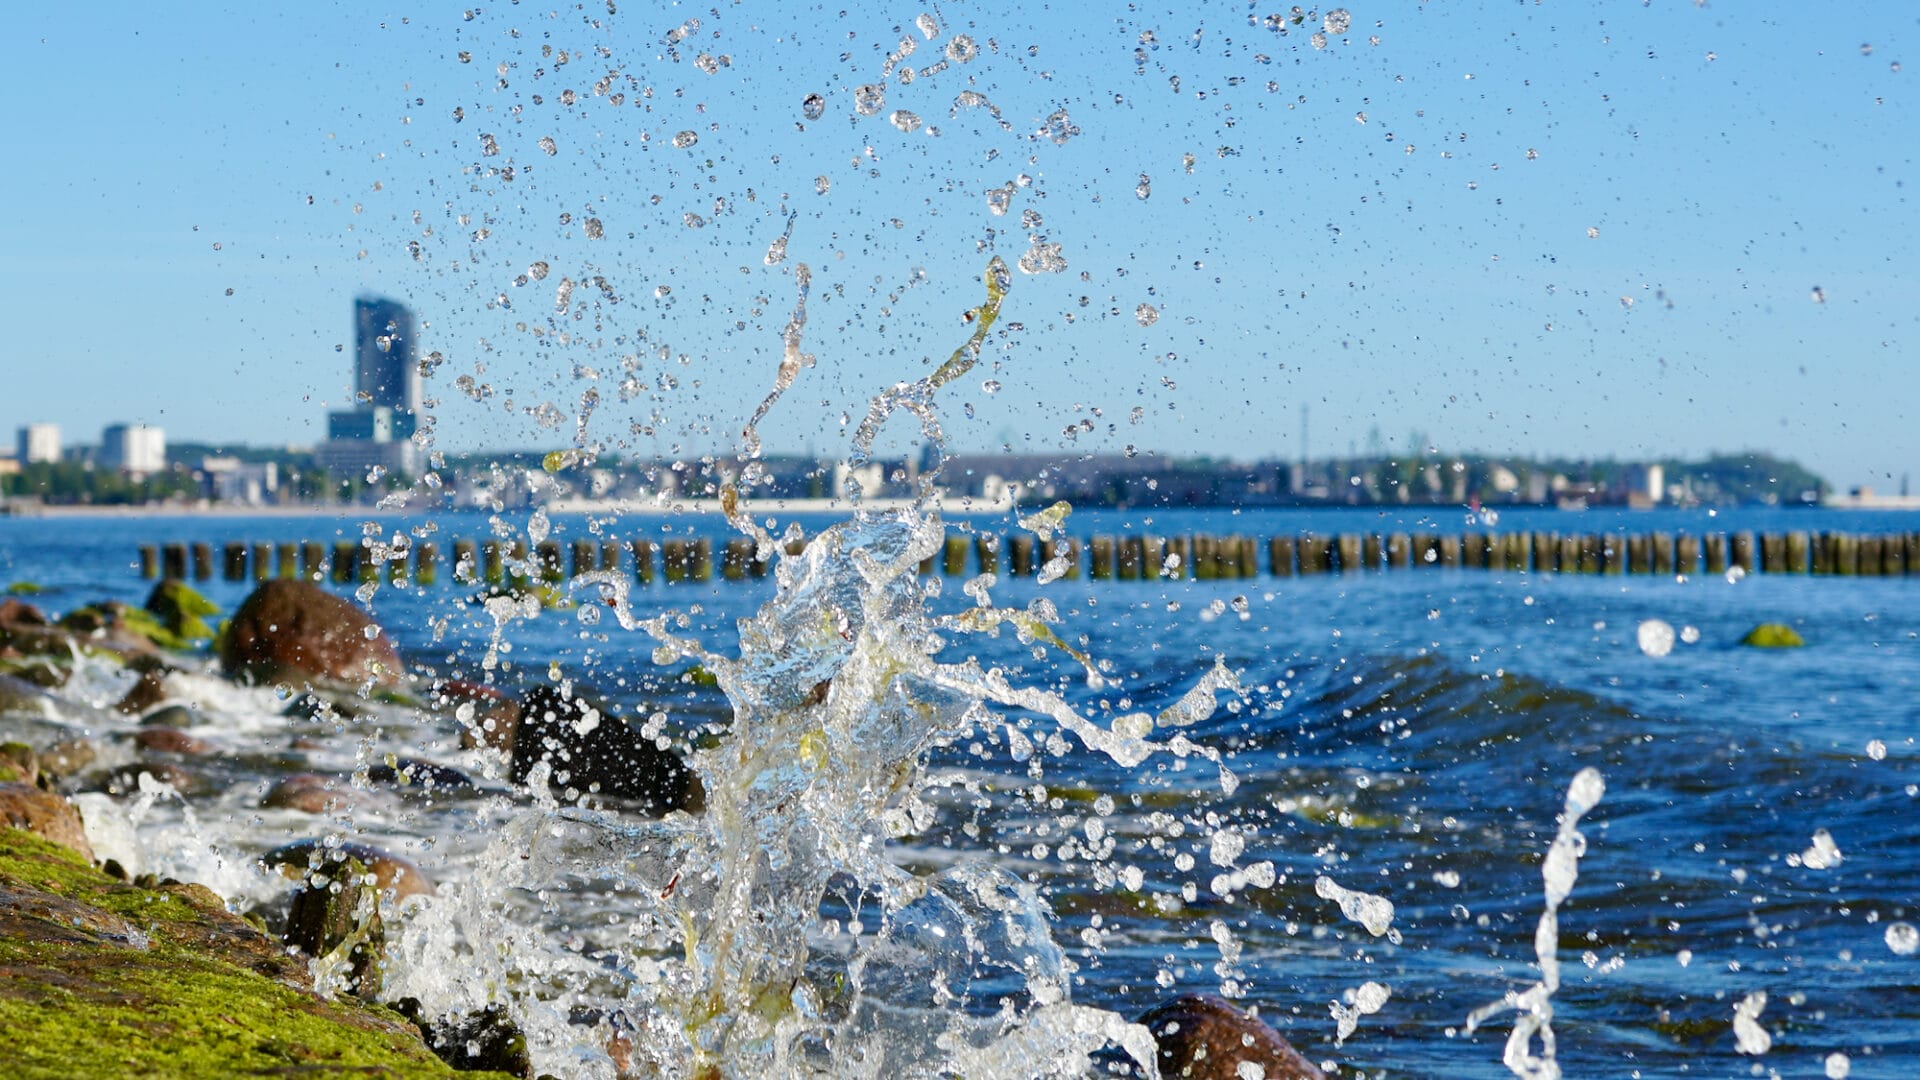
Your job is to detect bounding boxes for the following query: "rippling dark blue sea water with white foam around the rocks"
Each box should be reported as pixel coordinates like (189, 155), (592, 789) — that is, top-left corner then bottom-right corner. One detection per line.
(0, 511), (1920, 1076)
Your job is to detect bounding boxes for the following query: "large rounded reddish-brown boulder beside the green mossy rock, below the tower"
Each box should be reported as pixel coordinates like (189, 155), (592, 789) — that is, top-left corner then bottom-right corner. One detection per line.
(221, 580), (401, 686)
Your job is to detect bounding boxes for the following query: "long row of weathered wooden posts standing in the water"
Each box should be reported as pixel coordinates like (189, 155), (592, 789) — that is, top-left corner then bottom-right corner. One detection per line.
(140, 530), (1920, 584)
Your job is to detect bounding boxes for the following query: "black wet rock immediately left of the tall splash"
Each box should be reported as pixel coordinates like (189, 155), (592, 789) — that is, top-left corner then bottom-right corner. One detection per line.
(511, 686), (707, 817)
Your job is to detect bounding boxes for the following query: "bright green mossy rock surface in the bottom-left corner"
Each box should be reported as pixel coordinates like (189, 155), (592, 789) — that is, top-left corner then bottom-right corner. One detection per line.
(0, 828), (518, 1078)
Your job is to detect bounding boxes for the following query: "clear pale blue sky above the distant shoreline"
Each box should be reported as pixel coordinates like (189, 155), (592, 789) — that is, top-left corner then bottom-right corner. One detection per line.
(0, 0), (1920, 490)
